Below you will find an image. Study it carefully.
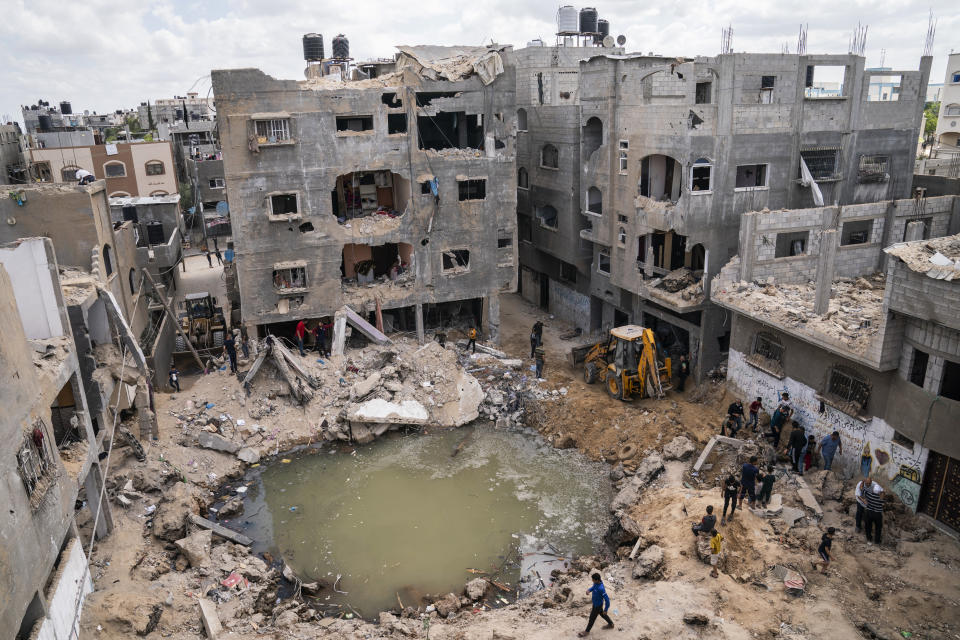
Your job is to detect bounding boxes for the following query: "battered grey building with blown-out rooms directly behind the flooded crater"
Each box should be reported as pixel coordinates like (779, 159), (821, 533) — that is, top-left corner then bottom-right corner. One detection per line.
(211, 46), (516, 340)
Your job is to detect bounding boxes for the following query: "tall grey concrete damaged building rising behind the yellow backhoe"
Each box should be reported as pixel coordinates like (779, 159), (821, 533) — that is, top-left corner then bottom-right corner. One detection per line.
(516, 47), (931, 375)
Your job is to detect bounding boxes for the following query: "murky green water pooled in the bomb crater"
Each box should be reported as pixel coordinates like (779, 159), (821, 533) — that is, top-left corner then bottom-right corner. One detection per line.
(237, 425), (611, 617)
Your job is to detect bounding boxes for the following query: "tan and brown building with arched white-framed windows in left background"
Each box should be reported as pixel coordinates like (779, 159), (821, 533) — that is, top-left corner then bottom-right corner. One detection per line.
(28, 142), (178, 198)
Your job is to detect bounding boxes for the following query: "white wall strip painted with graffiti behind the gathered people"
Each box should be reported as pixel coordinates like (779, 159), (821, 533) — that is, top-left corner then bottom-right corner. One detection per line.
(727, 349), (927, 490)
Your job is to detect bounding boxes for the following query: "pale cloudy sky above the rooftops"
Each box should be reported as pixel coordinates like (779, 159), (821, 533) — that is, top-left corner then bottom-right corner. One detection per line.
(0, 0), (960, 121)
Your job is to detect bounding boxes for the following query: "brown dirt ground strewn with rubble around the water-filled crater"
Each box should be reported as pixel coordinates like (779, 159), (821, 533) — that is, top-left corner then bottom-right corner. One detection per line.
(80, 292), (960, 640)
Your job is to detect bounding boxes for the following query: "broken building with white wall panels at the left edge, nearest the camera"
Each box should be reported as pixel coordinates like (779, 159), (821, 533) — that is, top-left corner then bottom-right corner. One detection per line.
(0, 238), (112, 638)
